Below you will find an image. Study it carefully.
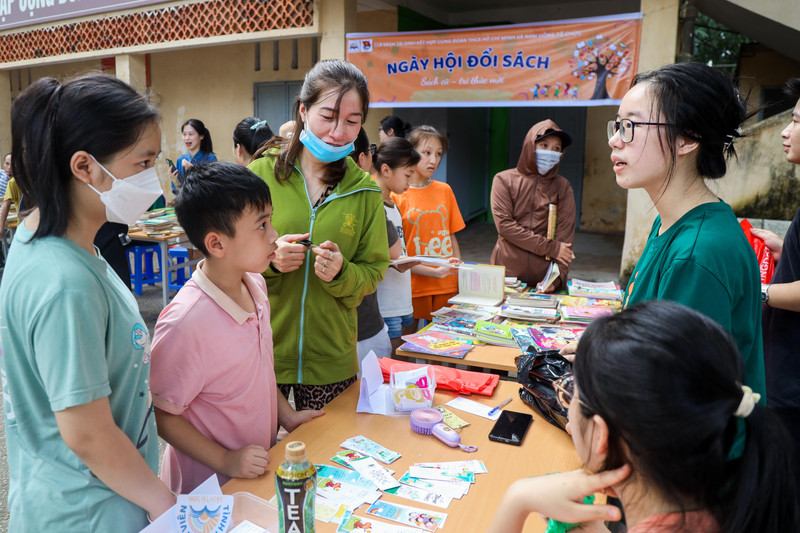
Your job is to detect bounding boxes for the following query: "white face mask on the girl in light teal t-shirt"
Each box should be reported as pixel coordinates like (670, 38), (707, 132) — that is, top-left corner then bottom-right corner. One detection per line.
(87, 156), (162, 226)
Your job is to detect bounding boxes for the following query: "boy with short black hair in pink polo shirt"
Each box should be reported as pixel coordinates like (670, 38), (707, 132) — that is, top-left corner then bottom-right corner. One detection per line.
(150, 163), (323, 493)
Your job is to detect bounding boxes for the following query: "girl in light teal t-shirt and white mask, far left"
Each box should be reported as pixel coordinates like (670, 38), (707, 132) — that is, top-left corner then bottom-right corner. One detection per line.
(0, 76), (175, 532)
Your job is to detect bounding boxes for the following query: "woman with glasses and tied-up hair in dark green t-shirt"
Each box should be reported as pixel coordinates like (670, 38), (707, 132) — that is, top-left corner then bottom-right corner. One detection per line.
(608, 63), (766, 396)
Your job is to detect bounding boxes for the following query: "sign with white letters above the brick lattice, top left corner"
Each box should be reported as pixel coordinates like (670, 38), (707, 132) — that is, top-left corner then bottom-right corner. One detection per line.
(0, 0), (165, 31)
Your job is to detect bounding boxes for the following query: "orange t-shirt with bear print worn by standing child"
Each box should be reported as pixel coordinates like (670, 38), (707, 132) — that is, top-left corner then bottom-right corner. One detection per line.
(392, 180), (465, 298)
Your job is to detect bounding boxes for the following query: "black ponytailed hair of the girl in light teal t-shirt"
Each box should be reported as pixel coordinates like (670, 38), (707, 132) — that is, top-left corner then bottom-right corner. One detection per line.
(11, 75), (159, 238)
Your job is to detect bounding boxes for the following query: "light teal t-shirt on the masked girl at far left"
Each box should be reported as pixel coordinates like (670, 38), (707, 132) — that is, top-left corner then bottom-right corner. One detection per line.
(0, 219), (158, 533)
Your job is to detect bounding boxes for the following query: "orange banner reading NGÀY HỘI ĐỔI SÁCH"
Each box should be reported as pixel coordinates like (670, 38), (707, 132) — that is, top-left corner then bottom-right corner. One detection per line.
(347, 13), (641, 107)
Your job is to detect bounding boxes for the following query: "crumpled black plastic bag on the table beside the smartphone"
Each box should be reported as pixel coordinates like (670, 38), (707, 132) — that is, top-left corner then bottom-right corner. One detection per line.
(516, 354), (572, 431)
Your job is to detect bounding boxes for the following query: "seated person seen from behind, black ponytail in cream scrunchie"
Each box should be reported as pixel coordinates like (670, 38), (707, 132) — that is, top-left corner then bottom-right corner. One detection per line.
(490, 301), (800, 533)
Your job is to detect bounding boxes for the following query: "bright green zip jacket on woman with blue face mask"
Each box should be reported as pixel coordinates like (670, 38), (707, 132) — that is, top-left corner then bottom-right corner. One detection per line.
(249, 154), (389, 385)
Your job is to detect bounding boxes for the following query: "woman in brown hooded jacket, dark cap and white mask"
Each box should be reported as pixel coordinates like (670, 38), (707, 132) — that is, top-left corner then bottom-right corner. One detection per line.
(491, 120), (575, 292)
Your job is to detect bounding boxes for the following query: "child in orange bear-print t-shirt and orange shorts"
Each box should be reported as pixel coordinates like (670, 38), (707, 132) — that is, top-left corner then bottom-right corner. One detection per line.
(392, 126), (465, 321)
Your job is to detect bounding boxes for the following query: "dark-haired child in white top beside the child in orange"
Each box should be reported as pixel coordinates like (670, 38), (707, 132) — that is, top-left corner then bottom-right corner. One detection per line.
(373, 137), (421, 355)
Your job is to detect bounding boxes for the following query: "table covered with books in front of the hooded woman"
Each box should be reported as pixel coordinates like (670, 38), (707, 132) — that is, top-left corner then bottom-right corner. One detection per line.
(397, 280), (622, 372)
